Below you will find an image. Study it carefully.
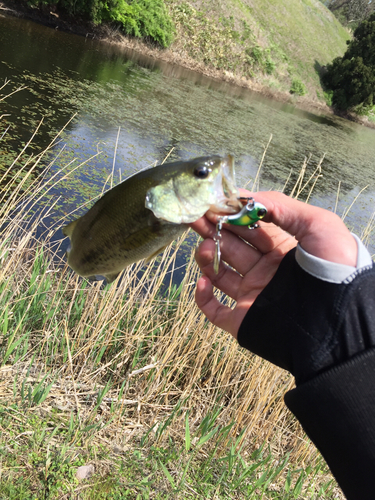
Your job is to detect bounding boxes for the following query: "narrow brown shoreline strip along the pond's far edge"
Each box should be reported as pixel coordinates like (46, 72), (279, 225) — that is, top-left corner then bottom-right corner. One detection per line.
(0, 0), (375, 128)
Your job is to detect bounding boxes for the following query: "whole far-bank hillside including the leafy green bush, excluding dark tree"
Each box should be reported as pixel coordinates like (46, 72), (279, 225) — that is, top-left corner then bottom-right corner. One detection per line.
(0, 0), (350, 102)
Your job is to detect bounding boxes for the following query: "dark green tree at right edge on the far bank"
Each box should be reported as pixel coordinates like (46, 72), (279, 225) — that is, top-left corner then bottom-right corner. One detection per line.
(322, 13), (375, 114)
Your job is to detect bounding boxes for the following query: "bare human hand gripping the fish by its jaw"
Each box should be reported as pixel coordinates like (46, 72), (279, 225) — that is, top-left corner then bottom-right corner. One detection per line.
(191, 190), (357, 338)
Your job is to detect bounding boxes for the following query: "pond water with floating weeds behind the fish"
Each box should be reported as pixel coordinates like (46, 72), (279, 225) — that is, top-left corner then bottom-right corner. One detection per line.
(0, 13), (375, 260)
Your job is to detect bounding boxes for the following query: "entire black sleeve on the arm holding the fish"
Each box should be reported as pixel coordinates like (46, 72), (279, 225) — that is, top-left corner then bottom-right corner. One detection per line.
(238, 251), (375, 500)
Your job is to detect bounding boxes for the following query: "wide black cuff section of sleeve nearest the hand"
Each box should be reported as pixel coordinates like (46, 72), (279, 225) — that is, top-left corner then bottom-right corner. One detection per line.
(238, 244), (375, 385)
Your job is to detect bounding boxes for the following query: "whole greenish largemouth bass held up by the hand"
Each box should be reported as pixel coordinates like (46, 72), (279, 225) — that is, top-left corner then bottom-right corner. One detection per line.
(62, 155), (242, 283)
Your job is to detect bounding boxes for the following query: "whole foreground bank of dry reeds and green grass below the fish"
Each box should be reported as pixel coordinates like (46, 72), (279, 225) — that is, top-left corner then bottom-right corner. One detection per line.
(0, 113), (346, 500)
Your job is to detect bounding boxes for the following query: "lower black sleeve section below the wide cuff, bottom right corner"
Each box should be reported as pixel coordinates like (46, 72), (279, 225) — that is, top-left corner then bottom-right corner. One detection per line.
(285, 348), (375, 500)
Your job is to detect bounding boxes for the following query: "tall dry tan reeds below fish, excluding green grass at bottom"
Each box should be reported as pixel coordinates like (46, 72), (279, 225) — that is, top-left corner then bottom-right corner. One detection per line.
(0, 112), (340, 498)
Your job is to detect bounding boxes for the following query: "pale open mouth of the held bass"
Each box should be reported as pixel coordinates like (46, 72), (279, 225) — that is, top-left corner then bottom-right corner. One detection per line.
(210, 155), (242, 213)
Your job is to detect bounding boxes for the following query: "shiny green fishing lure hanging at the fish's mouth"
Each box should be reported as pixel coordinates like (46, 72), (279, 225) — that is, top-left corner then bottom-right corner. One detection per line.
(214, 198), (267, 274)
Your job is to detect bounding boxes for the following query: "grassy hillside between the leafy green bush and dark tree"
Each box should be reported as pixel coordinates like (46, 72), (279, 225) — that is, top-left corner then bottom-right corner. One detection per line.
(166, 0), (350, 100)
